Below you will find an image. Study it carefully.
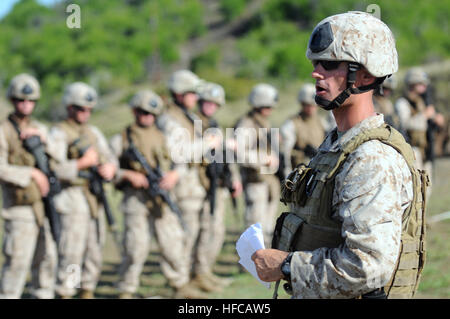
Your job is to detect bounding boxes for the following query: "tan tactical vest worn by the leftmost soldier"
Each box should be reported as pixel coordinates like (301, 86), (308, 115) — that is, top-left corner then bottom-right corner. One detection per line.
(3, 114), (45, 225)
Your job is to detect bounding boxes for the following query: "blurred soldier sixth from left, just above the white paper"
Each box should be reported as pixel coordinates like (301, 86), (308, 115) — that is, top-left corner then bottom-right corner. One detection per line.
(235, 83), (280, 249)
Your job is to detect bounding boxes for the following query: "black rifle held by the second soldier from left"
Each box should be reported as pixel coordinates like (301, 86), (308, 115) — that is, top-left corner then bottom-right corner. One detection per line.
(71, 138), (121, 250)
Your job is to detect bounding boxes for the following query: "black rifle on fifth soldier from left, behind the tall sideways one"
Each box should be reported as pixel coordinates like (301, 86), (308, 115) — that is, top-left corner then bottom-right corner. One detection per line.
(206, 149), (237, 215)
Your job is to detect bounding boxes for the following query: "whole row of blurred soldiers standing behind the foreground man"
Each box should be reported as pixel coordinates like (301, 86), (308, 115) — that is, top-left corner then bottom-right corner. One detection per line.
(0, 63), (443, 298)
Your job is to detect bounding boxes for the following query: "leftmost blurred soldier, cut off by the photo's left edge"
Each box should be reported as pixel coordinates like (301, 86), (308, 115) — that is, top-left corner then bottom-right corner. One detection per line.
(0, 74), (56, 298)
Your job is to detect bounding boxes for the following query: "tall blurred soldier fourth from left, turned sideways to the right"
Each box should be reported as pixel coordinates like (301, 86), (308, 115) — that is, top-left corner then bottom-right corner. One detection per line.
(157, 70), (221, 296)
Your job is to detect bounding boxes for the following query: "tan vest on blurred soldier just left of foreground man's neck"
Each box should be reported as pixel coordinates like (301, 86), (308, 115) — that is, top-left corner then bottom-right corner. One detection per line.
(291, 114), (325, 167)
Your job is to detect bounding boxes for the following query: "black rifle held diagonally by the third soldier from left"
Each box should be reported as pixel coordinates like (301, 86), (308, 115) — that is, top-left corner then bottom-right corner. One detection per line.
(122, 128), (188, 230)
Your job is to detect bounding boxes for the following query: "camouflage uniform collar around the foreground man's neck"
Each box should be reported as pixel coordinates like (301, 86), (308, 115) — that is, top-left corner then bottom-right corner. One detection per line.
(319, 114), (384, 152)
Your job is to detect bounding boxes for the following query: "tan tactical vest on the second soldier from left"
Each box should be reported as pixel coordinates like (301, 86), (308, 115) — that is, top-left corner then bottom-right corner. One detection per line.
(57, 119), (101, 218)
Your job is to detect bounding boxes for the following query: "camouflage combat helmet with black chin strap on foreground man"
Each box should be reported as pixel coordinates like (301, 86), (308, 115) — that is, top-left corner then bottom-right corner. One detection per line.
(306, 11), (398, 110)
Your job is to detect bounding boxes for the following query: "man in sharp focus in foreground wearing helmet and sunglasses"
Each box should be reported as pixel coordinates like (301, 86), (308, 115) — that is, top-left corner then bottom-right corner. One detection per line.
(252, 11), (426, 299)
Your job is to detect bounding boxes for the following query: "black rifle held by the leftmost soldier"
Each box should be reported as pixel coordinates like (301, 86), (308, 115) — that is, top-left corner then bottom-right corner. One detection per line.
(8, 117), (61, 243)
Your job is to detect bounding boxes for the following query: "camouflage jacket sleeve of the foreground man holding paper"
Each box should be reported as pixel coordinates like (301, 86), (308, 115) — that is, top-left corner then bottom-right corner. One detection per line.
(291, 141), (412, 298)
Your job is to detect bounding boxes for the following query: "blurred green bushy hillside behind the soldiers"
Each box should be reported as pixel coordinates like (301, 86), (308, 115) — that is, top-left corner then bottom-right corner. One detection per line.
(0, 0), (450, 120)
